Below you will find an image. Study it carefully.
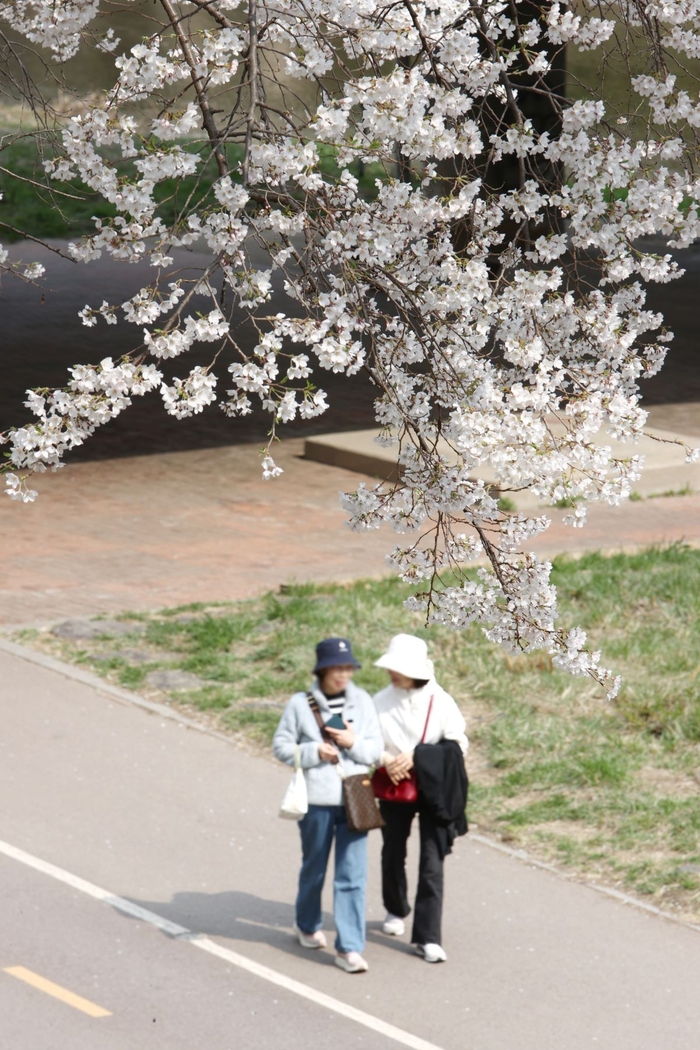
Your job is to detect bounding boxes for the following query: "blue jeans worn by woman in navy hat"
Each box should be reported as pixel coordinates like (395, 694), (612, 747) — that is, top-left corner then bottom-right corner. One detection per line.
(296, 805), (367, 952)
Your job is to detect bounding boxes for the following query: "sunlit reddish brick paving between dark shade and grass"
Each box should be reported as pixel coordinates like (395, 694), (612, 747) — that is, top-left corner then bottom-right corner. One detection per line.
(0, 439), (700, 624)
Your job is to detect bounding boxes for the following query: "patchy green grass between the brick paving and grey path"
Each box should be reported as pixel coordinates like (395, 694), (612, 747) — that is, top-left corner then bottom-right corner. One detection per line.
(22, 546), (700, 921)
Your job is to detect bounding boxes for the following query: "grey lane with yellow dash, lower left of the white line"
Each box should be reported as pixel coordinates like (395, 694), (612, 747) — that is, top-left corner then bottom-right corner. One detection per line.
(0, 858), (395, 1050)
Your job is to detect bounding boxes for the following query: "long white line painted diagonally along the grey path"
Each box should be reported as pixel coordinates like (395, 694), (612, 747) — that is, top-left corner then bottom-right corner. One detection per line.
(0, 840), (442, 1050)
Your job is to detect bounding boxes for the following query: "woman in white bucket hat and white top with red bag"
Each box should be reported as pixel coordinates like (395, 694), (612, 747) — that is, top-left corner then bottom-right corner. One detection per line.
(373, 634), (468, 963)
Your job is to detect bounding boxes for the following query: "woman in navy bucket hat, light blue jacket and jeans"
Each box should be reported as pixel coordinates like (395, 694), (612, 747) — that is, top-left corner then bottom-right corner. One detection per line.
(273, 638), (382, 973)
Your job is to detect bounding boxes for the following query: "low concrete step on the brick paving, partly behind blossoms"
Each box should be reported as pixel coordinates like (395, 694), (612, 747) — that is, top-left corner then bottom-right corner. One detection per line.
(304, 427), (700, 510)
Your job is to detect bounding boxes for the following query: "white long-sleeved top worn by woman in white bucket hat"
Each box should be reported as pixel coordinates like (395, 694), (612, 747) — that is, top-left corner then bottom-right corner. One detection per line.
(375, 679), (469, 764)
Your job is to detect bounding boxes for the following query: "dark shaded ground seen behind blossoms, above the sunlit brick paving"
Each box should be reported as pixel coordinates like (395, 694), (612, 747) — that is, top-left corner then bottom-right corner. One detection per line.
(0, 243), (700, 460)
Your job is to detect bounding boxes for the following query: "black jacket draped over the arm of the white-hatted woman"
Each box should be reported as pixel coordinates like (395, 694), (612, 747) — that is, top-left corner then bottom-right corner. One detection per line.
(413, 740), (469, 857)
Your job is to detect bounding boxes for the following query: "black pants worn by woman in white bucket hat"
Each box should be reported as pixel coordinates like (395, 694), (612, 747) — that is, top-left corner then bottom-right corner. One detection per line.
(380, 802), (443, 944)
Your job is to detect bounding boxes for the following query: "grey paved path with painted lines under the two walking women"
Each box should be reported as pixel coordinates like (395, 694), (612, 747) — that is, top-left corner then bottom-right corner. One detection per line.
(0, 644), (700, 1050)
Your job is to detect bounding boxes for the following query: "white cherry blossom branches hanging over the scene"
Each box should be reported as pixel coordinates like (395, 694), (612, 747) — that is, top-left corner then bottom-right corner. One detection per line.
(0, 0), (700, 695)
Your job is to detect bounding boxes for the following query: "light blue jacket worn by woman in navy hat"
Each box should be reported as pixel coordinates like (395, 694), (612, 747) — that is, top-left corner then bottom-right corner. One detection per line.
(272, 681), (383, 805)
